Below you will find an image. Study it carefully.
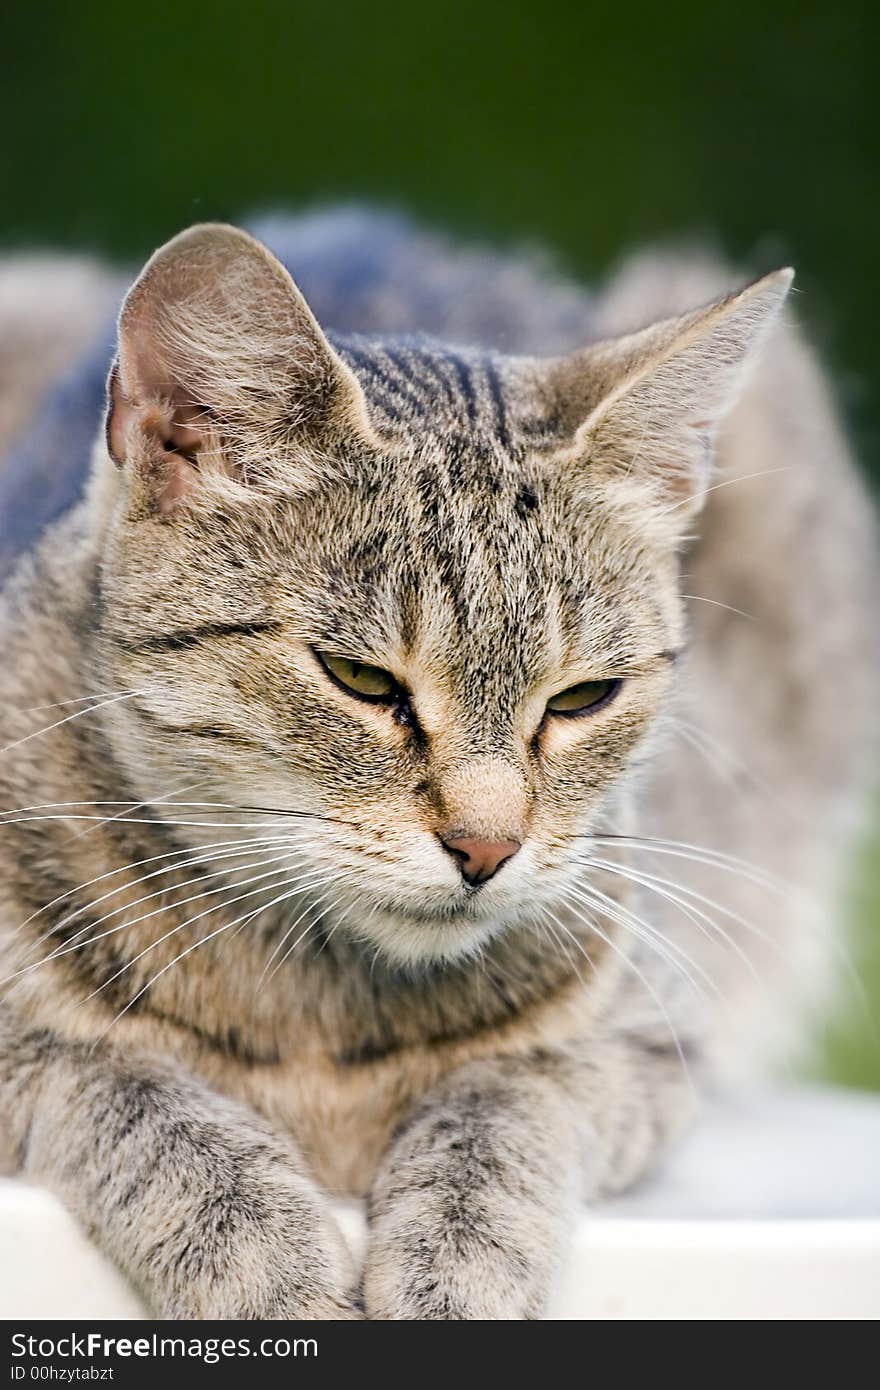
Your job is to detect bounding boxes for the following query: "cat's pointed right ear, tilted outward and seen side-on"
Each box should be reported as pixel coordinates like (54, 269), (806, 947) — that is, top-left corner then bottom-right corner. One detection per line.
(539, 270), (794, 523)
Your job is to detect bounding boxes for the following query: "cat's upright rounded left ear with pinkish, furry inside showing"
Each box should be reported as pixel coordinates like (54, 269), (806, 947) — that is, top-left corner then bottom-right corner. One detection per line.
(106, 224), (371, 516)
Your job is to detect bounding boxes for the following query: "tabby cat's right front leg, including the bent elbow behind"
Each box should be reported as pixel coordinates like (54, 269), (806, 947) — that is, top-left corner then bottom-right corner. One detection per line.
(364, 1037), (691, 1319)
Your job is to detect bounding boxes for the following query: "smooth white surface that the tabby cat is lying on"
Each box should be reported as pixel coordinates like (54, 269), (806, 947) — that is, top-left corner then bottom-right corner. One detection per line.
(0, 1091), (880, 1321)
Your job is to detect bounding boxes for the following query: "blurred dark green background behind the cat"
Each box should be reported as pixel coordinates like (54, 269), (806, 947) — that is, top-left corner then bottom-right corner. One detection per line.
(0, 0), (880, 1087)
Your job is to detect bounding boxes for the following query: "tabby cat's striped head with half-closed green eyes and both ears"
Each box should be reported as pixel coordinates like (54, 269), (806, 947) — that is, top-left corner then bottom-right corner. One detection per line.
(95, 227), (791, 962)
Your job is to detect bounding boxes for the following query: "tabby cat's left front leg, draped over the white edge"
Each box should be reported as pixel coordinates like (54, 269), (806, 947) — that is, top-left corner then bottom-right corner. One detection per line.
(0, 1019), (360, 1319)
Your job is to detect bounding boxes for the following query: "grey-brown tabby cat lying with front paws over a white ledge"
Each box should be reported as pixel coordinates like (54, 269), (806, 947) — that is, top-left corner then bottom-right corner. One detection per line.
(0, 209), (877, 1319)
